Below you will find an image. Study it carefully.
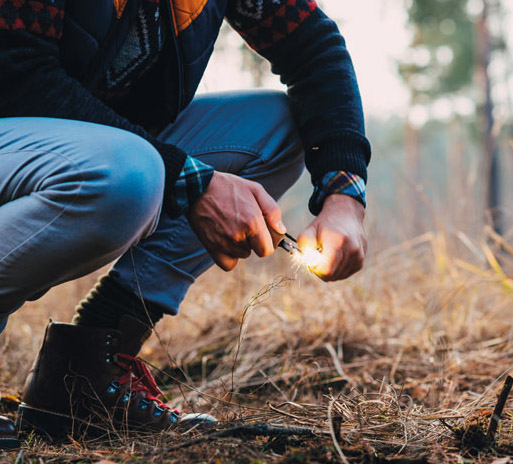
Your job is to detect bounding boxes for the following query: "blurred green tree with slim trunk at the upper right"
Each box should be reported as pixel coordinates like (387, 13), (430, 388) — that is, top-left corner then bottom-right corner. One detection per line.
(399, 0), (504, 230)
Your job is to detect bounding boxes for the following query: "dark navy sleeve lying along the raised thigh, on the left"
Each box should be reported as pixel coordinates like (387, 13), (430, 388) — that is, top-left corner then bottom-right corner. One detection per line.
(0, 23), (187, 216)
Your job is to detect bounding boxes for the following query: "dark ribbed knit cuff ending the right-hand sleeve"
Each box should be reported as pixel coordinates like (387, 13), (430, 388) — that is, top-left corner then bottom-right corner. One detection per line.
(305, 130), (371, 185)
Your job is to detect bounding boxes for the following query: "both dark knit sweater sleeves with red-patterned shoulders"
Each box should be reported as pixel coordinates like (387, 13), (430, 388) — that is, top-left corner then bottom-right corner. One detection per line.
(0, 0), (370, 216)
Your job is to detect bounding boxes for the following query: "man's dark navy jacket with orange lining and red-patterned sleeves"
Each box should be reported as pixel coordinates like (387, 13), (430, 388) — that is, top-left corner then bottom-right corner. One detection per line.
(0, 0), (370, 215)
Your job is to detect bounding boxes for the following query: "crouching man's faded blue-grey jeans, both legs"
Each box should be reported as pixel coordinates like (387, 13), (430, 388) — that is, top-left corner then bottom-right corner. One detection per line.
(0, 91), (304, 331)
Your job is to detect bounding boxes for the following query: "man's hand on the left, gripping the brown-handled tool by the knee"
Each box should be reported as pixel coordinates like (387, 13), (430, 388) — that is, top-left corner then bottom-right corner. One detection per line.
(187, 171), (286, 271)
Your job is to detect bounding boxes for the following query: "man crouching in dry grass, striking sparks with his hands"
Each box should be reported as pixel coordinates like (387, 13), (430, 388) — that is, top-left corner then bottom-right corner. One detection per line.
(0, 0), (370, 447)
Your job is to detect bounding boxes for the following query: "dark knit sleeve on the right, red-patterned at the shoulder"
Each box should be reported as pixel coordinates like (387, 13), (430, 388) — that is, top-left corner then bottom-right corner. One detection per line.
(226, 0), (371, 192)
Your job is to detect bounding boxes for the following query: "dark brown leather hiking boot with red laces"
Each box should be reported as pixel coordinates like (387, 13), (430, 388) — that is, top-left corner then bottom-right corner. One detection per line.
(17, 315), (213, 440)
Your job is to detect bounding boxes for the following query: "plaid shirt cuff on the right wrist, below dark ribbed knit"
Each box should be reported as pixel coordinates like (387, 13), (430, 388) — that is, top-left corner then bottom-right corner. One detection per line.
(308, 171), (367, 215)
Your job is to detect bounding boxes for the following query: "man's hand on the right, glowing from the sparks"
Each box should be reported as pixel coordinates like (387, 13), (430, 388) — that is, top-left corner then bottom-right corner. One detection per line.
(297, 194), (367, 282)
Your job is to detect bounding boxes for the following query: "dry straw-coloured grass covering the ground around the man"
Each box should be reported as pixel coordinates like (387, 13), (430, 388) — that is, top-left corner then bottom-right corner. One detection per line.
(0, 226), (513, 464)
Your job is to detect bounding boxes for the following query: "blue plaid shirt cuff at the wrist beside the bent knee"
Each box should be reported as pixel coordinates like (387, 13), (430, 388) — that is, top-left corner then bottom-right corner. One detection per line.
(173, 156), (214, 214)
